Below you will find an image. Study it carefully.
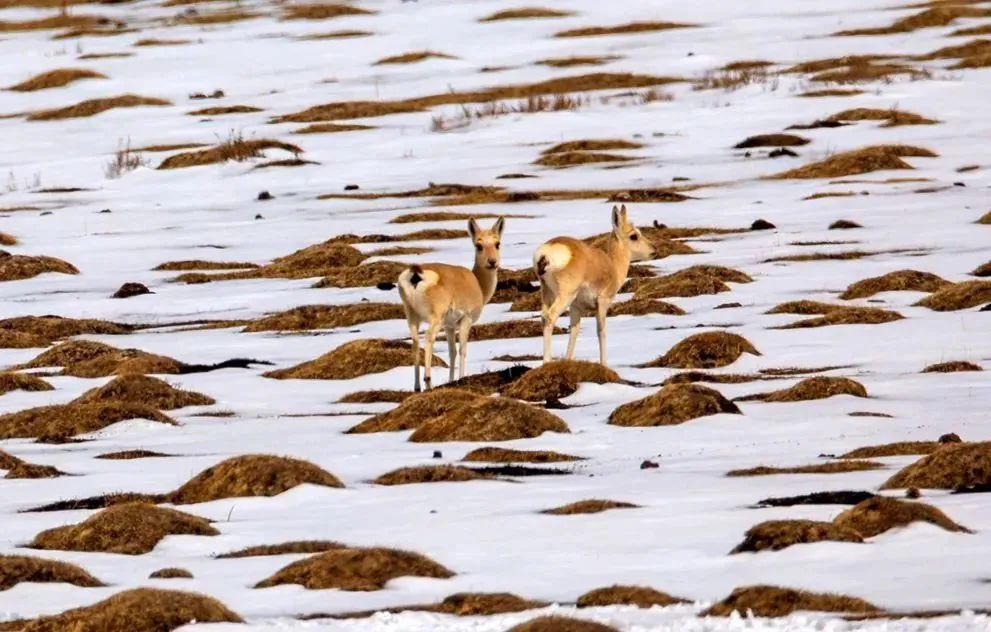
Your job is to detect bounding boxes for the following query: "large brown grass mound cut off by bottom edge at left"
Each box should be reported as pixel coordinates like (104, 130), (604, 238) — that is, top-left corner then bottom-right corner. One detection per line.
(18, 588), (242, 632)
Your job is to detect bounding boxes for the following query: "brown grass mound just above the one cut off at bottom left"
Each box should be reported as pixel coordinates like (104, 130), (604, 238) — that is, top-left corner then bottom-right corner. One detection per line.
(28, 503), (220, 555)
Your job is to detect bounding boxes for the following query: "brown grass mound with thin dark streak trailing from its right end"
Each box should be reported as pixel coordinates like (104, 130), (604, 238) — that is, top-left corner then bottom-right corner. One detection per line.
(14, 340), (182, 377)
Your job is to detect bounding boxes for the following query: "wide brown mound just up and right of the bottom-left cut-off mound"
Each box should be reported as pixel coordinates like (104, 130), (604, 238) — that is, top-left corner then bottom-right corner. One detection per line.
(255, 548), (454, 591)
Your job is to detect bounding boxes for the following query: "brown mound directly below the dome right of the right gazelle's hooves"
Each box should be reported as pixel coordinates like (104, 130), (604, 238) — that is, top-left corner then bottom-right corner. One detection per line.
(609, 384), (741, 427)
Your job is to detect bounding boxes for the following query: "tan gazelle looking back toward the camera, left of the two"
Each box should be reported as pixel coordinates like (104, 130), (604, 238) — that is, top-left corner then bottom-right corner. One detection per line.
(398, 217), (506, 392)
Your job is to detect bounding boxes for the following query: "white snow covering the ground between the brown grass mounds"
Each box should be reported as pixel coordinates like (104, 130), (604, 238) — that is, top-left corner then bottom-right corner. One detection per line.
(0, 0), (991, 631)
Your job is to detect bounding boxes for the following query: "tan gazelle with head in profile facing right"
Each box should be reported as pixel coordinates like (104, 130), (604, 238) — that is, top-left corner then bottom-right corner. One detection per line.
(533, 204), (655, 366)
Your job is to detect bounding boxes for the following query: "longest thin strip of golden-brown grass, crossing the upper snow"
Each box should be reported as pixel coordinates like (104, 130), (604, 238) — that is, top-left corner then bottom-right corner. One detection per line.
(273, 73), (678, 123)
